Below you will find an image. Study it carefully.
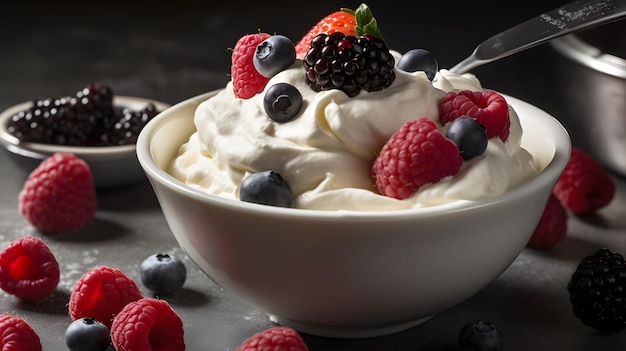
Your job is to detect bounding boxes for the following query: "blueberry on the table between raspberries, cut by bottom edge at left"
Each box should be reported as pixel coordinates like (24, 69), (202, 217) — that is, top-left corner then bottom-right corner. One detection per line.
(65, 318), (111, 351)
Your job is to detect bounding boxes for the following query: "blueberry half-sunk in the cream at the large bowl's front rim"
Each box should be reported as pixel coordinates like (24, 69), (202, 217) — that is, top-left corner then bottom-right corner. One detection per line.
(239, 171), (293, 207)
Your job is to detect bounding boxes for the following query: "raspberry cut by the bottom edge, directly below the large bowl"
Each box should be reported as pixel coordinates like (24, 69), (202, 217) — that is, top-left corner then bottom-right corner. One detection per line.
(237, 327), (309, 351)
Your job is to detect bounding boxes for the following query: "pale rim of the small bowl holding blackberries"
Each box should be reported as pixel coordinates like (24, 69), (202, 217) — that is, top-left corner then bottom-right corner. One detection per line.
(0, 95), (170, 161)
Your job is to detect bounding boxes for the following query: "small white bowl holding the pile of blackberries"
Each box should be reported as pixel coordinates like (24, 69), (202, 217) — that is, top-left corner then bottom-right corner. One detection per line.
(0, 96), (169, 188)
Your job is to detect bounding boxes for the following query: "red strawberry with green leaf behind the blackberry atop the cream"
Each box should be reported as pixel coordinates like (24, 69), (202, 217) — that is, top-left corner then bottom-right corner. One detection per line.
(296, 4), (383, 60)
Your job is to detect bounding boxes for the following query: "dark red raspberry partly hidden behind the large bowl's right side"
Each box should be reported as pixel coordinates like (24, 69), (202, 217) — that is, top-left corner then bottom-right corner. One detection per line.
(528, 193), (567, 250)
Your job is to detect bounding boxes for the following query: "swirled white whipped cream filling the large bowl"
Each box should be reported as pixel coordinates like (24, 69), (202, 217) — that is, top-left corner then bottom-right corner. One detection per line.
(169, 53), (537, 211)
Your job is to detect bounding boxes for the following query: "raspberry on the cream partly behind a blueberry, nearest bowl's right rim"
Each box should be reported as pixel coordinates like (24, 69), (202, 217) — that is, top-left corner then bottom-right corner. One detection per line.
(439, 90), (511, 141)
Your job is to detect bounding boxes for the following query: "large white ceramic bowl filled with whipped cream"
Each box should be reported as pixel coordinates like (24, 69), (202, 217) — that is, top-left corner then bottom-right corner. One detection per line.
(137, 93), (570, 338)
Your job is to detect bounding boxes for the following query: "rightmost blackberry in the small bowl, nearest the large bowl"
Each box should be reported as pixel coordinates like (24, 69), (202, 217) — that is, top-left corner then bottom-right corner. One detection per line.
(107, 103), (158, 145)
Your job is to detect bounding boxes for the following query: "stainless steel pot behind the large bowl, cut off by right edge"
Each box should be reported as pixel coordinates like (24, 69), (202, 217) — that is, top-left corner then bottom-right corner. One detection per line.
(551, 21), (626, 176)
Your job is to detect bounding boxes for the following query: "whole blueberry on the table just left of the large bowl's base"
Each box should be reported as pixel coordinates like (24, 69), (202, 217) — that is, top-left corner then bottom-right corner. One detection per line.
(139, 253), (187, 295)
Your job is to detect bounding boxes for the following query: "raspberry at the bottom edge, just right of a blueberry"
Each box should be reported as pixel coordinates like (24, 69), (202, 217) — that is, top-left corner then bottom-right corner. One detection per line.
(111, 298), (185, 351)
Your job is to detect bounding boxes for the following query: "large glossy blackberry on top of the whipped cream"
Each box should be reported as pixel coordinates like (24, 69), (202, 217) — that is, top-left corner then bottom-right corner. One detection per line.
(304, 32), (396, 97)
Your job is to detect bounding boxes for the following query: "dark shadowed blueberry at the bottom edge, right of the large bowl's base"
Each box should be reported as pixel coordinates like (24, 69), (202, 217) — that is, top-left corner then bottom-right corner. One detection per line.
(459, 321), (504, 351)
